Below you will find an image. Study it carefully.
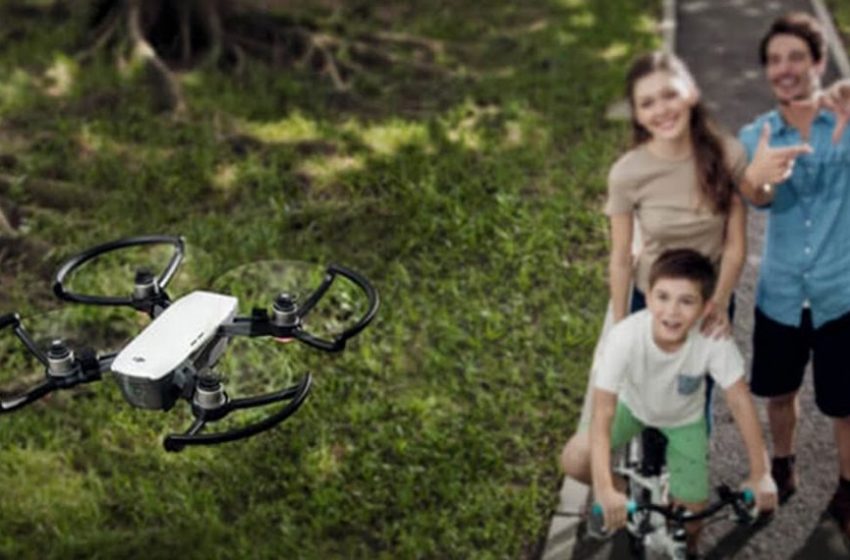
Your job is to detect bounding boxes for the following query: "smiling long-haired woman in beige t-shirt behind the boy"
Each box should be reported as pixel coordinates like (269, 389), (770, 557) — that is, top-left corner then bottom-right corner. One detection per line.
(605, 52), (747, 336)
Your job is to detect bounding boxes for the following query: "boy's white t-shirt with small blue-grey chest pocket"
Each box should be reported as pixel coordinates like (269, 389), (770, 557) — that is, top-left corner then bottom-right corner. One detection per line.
(595, 309), (744, 428)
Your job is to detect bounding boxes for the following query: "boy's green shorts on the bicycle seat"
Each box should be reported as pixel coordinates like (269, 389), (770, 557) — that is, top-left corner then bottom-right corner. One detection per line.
(611, 401), (709, 503)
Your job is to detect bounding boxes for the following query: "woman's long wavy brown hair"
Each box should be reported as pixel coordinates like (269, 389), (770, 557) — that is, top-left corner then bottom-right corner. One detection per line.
(626, 51), (735, 214)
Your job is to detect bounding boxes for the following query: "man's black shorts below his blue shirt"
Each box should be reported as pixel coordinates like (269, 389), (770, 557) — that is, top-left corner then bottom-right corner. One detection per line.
(750, 307), (850, 418)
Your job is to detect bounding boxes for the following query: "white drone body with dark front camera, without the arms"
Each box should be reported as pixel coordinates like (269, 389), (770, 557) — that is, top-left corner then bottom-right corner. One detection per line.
(111, 291), (238, 410)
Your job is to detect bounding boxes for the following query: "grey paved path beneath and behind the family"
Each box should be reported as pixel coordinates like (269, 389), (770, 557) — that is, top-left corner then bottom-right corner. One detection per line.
(543, 0), (850, 560)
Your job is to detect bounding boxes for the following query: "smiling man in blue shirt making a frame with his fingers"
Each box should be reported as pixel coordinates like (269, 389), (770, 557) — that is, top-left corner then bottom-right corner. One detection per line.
(739, 13), (850, 535)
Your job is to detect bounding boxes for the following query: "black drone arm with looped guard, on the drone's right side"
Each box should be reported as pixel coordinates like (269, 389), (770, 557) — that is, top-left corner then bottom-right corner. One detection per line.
(220, 264), (380, 352)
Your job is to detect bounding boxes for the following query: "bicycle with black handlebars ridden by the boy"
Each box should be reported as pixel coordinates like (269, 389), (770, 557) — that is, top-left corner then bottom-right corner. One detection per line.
(587, 428), (757, 560)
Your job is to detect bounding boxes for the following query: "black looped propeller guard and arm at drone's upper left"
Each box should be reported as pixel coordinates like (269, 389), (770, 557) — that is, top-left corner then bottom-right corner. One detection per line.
(53, 235), (184, 316)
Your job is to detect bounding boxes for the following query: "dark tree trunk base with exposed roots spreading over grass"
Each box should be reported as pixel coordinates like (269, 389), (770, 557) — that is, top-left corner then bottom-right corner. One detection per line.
(71, 0), (443, 113)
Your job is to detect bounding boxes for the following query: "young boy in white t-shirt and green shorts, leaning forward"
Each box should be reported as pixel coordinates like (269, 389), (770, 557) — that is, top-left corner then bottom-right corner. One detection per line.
(561, 249), (776, 553)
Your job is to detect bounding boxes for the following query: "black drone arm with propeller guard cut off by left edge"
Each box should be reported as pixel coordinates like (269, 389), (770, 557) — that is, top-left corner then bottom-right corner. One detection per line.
(0, 313), (113, 414)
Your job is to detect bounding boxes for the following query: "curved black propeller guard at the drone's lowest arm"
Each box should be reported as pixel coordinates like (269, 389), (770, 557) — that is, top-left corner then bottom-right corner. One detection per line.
(163, 373), (313, 451)
